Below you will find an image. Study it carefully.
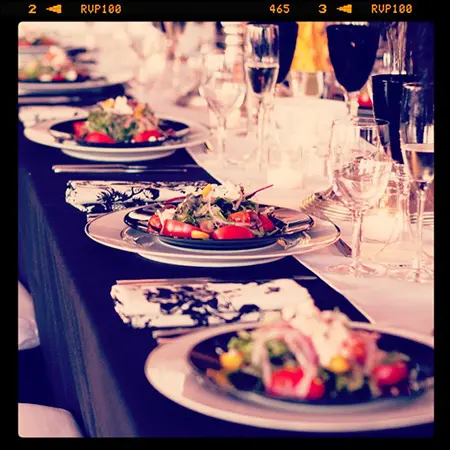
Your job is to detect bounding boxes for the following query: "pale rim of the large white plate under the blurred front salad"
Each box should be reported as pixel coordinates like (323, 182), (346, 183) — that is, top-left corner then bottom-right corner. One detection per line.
(144, 322), (434, 433)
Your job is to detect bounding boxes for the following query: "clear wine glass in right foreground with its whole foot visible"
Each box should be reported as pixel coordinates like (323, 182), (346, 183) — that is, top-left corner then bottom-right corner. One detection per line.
(328, 117), (392, 277)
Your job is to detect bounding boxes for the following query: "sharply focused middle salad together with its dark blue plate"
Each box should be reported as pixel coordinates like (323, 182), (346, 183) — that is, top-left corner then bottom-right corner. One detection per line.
(124, 182), (314, 251)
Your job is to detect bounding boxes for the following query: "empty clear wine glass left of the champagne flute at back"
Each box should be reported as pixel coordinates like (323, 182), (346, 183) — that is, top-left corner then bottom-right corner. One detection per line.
(199, 50), (246, 165)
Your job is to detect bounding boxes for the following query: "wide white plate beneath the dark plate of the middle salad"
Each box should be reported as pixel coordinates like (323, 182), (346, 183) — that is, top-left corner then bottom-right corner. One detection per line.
(85, 206), (340, 267)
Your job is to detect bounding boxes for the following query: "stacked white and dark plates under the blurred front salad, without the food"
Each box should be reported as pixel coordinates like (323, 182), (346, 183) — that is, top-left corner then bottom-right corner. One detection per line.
(145, 323), (434, 433)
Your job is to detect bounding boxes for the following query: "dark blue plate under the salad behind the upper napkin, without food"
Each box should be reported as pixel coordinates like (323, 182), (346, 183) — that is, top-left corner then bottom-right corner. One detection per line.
(49, 119), (189, 148)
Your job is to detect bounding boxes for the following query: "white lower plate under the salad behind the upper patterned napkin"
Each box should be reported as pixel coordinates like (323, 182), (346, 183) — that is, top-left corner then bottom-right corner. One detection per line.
(24, 115), (211, 162)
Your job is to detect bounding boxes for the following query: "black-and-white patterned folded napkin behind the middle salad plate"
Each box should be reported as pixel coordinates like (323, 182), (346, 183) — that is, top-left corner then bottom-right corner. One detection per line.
(66, 180), (207, 214)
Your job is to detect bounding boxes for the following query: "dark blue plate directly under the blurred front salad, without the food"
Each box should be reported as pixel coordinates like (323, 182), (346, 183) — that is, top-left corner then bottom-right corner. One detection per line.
(188, 326), (434, 409)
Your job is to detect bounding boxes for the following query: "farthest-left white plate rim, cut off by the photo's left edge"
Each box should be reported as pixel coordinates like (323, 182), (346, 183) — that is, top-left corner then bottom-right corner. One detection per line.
(18, 73), (132, 96)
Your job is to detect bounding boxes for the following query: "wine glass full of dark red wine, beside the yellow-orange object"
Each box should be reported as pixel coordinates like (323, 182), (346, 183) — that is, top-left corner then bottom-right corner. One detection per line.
(327, 23), (380, 116)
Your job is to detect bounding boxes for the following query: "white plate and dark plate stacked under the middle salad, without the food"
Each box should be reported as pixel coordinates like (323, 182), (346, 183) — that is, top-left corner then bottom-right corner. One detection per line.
(85, 206), (340, 267)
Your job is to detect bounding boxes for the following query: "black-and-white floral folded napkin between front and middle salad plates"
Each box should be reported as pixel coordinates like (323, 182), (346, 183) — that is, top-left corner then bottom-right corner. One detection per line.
(111, 279), (311, 329)
